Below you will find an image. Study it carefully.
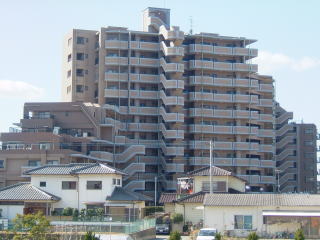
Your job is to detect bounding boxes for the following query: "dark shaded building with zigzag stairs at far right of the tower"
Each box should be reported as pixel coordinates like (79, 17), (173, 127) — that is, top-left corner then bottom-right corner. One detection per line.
(276, 103), (317, 193)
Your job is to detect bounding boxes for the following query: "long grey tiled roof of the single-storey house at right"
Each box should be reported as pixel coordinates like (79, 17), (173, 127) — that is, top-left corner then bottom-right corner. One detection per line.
(204, 194), (320, 206)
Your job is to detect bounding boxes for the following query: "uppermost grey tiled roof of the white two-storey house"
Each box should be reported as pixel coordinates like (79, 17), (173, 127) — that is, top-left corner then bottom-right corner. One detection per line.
(25, 163), (126, 175)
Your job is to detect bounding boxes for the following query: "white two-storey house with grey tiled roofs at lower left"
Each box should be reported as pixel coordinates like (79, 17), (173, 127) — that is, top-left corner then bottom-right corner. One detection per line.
(0, 163), (151, 220)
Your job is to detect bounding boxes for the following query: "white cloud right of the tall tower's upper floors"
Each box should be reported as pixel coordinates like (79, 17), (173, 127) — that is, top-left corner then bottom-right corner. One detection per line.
(253, 51), (320, 74)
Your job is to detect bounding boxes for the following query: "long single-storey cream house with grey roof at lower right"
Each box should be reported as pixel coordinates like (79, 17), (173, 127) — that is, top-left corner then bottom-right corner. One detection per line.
(203, 194), (320, 239)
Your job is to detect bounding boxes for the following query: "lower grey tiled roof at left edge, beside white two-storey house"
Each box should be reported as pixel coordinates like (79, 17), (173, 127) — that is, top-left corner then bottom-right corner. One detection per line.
(0, 182), (60, 201)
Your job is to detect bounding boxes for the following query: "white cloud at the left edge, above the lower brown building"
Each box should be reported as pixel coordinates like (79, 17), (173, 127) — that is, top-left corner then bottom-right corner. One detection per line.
(0, 80), (44, 100)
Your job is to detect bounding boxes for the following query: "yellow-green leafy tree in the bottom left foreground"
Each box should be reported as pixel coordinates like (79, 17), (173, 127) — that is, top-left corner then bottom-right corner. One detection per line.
(13, 212), (50, 240)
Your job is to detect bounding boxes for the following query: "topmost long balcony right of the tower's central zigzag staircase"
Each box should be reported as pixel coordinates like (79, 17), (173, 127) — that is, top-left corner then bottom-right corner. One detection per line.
(189, 44), (258, 57)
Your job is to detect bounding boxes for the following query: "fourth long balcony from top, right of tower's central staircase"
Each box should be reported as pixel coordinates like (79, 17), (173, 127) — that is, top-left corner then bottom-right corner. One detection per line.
(189, 92), (259, 104)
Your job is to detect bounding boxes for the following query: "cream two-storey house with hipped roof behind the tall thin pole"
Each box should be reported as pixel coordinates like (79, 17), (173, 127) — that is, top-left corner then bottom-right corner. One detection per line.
(159, 166), (246, 224)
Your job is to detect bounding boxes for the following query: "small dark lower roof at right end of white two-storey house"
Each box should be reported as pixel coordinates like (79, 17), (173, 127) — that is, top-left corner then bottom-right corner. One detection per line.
(106, 187), (152, 201)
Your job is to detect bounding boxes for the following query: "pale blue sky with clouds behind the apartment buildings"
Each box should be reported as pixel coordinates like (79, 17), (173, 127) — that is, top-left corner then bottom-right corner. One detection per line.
(0, 0), (320, 132)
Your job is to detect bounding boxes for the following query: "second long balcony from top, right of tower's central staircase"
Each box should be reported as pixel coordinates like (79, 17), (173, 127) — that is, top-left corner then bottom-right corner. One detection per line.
(189, 60), (258, 72)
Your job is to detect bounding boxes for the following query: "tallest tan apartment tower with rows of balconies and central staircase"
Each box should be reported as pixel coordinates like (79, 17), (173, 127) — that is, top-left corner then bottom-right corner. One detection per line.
(58, 8), (276, 191)
